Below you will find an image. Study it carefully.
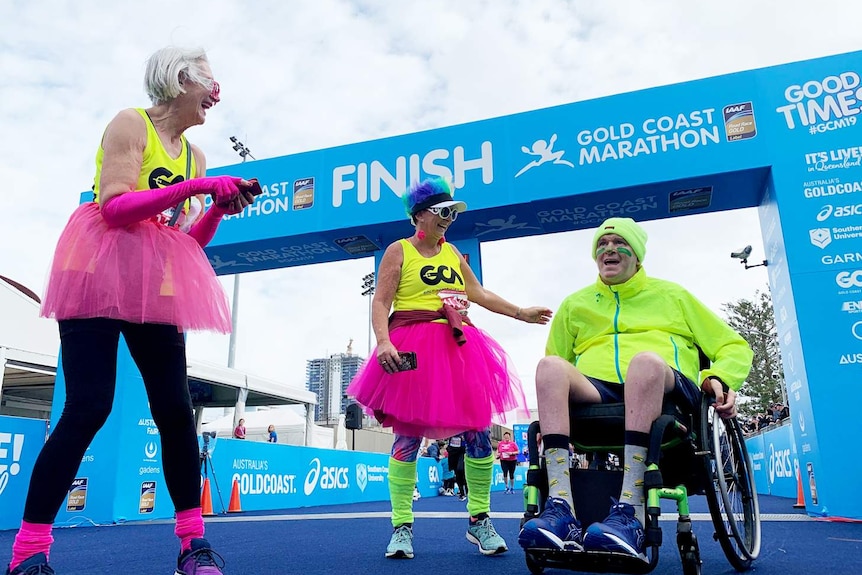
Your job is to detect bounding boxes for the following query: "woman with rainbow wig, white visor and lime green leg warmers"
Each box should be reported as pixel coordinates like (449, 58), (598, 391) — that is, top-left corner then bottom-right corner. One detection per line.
(347, 178), (551, 559)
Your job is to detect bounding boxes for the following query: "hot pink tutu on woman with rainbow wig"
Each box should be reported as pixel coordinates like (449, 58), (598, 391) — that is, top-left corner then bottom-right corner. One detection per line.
(347, 322), (528, 439)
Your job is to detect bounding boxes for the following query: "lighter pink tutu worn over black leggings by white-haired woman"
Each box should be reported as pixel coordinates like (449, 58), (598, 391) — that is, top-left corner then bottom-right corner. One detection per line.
(41, 202), (231, 333)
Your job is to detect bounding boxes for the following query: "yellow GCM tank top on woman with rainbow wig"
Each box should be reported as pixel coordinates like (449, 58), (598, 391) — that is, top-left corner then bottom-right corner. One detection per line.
(392, 239), (469, 321)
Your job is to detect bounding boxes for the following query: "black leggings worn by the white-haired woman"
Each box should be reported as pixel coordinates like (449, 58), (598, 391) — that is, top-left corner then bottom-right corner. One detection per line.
(24, 318), (200, 524)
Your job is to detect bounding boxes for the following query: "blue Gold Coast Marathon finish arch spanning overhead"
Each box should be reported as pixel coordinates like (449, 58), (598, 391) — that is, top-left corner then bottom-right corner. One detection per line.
(207, 52), (862, 519)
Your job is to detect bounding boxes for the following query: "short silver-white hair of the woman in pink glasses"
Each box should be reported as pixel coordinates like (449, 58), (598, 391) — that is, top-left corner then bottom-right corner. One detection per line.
(144, 46), (213, 105)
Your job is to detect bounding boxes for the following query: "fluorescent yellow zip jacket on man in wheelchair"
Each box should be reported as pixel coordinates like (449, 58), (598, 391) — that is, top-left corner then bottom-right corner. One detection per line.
(545, 268), (753, 390)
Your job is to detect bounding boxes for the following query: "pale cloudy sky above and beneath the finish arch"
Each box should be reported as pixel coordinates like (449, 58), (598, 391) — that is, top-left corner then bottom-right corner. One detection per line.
(0, 0), (862, 412)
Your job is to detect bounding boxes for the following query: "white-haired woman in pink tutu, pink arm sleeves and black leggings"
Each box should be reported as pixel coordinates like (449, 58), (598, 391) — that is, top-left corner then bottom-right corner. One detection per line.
(7, 48), (256, 575)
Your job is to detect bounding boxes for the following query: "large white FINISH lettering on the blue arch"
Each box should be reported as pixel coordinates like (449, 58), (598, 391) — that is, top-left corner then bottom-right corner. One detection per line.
(332, 141), (494, 208)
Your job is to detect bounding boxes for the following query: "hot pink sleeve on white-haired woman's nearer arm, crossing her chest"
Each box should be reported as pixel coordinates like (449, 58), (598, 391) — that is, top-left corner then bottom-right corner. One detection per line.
(101, 176), (242, 228)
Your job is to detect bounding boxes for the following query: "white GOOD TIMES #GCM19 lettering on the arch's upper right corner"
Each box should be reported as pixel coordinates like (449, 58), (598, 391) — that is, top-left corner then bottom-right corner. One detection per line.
(775, 72), (862, 134)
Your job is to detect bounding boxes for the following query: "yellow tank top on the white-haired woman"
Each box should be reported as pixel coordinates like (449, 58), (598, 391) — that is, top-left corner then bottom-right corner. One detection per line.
(93, 108), (197, 204)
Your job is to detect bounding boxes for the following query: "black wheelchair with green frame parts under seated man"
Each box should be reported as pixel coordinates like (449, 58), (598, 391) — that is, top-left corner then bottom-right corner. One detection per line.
(521, 395), (761, 575)
